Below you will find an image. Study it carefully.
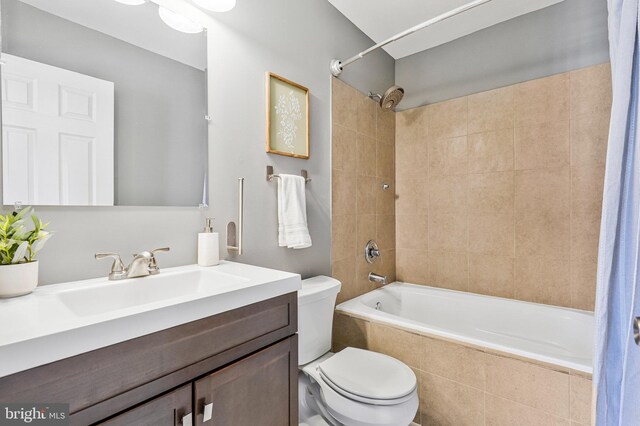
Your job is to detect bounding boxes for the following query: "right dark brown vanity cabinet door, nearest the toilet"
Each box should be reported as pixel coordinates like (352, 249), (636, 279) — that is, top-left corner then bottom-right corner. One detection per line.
(195, 336), (298, 426)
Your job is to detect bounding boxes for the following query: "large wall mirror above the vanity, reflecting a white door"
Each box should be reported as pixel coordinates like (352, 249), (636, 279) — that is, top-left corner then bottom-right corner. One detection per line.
(0, 0), (208, 206)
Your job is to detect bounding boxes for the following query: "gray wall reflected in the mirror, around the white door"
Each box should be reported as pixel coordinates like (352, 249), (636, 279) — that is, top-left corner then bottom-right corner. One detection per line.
(2, 0), (207, 206)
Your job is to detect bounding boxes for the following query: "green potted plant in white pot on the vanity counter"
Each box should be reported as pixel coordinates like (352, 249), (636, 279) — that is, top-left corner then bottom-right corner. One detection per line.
(0, 207), (51, 297)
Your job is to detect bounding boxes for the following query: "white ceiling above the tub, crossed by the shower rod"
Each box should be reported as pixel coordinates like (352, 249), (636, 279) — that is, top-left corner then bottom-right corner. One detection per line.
(329, 0), (563, 59)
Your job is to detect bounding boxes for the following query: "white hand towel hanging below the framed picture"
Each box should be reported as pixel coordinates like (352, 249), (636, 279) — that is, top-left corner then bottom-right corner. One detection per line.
(278, 174), (311, 249)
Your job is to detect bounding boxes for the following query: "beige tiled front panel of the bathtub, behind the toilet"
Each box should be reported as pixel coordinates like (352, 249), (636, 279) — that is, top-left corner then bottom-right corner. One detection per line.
(333, 313), (591, 426)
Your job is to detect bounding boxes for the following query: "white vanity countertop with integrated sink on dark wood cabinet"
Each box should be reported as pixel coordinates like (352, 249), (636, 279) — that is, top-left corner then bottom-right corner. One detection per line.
(0, 261), (301, 377)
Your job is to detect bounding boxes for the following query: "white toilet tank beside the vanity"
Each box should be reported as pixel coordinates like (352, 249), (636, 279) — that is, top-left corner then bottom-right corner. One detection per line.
(298, 275), (341, 365)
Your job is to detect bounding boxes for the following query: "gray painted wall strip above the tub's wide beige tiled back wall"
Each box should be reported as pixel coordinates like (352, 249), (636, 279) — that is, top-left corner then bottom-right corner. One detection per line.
(396, 0), (609, 110)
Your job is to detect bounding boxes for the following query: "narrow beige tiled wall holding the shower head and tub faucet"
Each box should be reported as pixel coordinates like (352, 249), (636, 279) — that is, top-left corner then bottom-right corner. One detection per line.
(331, 78), (396, 303)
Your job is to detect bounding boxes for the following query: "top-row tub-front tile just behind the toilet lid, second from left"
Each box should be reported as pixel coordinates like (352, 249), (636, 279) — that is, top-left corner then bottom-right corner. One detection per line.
(369, 322), (422, 368)
